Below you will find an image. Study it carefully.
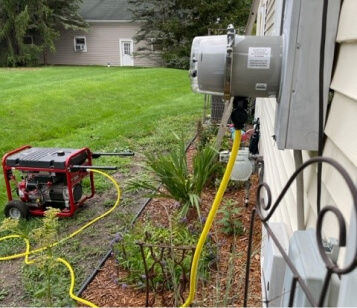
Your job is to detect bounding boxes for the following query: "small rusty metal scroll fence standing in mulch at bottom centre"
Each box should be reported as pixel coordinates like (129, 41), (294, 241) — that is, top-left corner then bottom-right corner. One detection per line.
(136, 232), (195, 307)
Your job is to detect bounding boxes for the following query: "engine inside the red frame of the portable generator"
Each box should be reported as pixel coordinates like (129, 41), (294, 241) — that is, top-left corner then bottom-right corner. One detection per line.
(17, 172), (83, 208)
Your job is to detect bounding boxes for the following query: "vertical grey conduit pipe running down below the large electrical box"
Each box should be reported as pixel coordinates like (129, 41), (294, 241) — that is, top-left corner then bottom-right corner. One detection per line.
(294, 150), (305, 230)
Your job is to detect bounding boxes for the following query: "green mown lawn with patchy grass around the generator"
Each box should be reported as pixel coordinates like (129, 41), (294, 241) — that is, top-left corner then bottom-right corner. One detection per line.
(0, 67), (202, 305)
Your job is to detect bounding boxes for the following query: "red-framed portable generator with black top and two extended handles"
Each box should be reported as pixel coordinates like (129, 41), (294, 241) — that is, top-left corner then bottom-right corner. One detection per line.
(2, 146), (134, 219)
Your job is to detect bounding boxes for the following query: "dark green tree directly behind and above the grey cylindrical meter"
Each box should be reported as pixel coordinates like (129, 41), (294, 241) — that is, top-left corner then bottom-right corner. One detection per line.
(129, 0), (251, 69)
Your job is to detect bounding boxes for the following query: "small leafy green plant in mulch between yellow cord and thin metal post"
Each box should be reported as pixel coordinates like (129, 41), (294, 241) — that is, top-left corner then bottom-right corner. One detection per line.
(218, 200), (244, 235)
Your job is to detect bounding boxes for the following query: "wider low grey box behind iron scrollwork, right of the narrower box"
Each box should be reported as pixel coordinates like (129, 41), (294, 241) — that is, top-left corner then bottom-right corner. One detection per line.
(281, 229), (339, 307)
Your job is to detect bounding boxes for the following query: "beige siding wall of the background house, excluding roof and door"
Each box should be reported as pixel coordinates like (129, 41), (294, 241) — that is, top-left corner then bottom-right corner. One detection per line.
(48, 22), (160, 67)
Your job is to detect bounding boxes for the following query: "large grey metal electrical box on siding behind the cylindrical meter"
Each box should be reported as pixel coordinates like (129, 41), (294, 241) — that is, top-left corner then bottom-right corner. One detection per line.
(275, 0), (340, 150)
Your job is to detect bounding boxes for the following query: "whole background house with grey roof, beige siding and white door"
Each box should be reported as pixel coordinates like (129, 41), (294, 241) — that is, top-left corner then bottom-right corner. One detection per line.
(48, 0), (161, 67)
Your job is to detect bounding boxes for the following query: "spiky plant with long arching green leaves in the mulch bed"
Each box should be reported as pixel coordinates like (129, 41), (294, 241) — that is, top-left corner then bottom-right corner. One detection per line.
(129, 138), (219, 218)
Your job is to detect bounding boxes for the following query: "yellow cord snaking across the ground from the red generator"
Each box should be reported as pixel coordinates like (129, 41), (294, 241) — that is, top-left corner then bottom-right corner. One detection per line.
(0, 169), (121, 307)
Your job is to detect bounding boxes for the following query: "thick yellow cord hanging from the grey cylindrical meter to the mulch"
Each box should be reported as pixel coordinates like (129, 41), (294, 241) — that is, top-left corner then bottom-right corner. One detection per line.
(182, 130), (241, 307)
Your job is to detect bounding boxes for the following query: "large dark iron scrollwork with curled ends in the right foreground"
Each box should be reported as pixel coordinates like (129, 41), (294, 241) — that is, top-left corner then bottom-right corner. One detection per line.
(244, 157), (357, 307)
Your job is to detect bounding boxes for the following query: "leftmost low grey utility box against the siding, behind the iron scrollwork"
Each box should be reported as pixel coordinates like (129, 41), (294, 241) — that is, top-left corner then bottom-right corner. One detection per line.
(261, 223), (289, 307)
